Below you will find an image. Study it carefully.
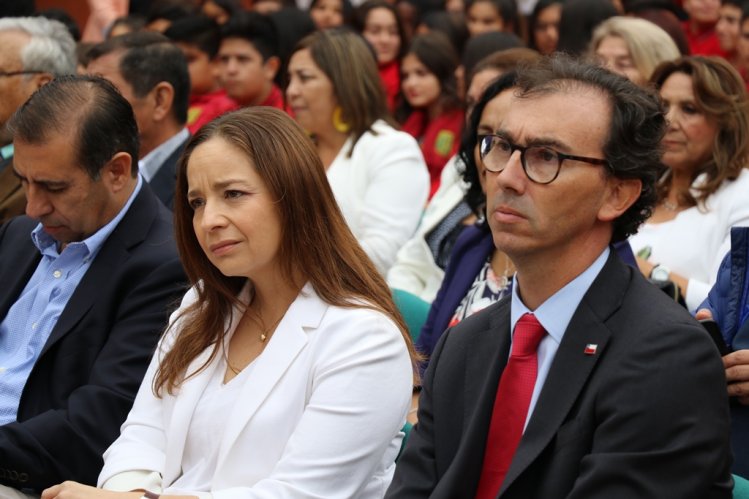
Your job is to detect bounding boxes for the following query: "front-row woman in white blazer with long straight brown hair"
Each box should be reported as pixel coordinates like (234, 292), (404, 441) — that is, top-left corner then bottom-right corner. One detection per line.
(42, 107), (413, 499)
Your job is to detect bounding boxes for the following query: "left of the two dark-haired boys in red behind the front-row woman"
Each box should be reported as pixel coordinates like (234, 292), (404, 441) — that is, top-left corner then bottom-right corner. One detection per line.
(164, 16), (238, 134)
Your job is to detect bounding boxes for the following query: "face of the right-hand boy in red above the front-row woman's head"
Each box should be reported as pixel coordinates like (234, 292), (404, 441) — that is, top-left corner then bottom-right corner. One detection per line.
(218, 38), (275, 106)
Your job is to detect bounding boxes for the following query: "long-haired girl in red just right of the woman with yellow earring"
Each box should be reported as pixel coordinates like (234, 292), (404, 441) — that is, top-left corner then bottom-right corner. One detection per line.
(396, 33), (465, 197)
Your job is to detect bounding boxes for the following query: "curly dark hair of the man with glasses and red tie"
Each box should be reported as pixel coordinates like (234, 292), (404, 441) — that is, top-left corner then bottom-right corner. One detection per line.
(517, 54), (666, 242)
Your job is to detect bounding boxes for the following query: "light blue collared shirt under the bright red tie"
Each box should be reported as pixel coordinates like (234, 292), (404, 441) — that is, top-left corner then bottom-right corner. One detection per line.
(510, 247), (611, 431)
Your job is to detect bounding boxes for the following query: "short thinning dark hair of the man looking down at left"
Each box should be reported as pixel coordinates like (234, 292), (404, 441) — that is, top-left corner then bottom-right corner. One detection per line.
(8, 75), (139, 180)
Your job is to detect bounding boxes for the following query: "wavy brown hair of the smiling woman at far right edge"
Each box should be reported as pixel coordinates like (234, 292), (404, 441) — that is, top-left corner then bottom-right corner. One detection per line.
(650, 56), (749, 207)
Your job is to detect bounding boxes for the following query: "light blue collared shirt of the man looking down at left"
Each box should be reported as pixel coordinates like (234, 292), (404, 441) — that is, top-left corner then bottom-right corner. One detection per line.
(0, 176), (143, 425)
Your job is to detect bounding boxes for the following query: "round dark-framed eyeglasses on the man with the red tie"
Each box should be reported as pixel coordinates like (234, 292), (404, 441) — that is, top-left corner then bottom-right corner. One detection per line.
(478, 135), (610, 184)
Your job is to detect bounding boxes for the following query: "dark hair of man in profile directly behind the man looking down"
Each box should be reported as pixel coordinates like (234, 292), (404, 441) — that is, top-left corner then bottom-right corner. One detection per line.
(88, 31), (190, 124)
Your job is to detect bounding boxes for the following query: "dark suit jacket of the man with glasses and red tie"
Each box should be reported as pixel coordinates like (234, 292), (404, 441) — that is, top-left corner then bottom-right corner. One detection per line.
(386, 254), (732, 499)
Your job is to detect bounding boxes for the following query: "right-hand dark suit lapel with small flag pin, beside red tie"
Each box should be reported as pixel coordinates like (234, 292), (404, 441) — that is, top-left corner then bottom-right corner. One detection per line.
(500, 252), (630, 495)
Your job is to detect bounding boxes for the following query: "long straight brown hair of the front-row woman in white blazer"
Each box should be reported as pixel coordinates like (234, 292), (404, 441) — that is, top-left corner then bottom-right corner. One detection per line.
(153, 106), (416, 395)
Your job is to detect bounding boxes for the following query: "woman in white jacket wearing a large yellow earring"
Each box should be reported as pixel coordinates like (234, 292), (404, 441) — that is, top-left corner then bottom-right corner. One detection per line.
(286, 29), (429, 275)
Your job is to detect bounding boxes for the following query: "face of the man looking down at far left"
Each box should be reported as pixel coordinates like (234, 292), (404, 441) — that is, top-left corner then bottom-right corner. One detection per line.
(13, 133), (121, 245)
